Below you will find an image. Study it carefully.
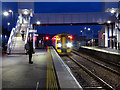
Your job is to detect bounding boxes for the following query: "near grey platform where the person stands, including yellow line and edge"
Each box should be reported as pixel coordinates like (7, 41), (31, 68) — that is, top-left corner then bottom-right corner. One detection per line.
(0, 47), (82, 90)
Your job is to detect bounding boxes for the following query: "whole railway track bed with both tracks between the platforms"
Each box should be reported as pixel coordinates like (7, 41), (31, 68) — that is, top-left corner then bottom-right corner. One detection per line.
(61, 51), (120, 90)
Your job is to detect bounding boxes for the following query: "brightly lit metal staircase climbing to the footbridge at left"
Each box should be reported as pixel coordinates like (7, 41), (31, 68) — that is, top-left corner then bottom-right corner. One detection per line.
(7, 9), (33, 54)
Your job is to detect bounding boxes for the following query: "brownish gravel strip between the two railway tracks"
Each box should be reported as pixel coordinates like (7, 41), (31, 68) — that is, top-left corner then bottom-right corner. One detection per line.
(71, 53), (120, 90)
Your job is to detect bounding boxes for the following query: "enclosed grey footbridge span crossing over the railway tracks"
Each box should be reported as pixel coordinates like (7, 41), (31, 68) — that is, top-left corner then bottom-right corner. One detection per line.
(31, 12), (117, 25)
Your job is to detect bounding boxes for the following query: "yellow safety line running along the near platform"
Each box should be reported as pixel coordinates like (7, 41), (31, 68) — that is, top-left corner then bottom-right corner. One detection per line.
(47, 47), (58, 90)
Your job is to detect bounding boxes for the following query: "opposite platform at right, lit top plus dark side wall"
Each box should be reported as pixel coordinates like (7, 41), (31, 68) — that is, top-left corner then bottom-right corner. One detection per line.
(79, 46), (120, 65)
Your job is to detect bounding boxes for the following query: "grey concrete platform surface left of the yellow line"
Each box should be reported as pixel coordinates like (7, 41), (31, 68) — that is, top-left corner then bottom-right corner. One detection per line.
(2, 50), (47, 90)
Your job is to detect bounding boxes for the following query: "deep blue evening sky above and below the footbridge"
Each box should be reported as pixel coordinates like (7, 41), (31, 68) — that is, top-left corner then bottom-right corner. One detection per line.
(2, 2), (102, 35)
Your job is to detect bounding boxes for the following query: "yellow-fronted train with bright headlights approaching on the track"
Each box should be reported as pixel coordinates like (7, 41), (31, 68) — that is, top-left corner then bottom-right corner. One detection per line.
(52, 33), (73, 55)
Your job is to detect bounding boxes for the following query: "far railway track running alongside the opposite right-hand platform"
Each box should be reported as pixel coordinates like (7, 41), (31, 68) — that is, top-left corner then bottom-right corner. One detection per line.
(72, 50), (120, 76)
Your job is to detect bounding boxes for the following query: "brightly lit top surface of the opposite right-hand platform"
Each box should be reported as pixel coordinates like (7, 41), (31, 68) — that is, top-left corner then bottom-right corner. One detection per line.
(81, 46), (120, 55)
